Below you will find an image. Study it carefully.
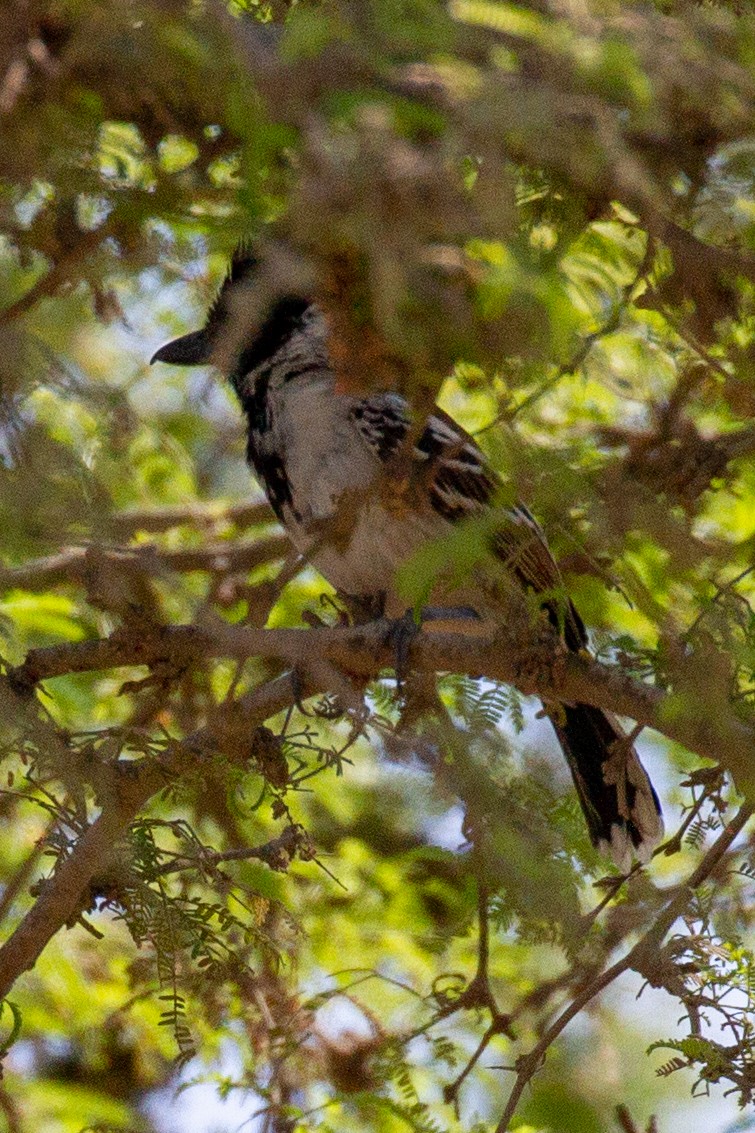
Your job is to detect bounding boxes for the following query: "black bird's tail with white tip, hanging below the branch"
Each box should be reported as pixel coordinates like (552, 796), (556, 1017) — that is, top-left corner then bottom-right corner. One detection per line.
(549, 705), (663, 871)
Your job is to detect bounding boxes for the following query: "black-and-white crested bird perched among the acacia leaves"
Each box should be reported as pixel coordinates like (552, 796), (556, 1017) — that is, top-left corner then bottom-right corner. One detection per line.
(152, 245), (663, 872)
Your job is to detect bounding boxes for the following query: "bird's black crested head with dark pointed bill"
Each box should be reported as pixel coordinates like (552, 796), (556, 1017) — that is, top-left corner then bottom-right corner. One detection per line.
(151, 246), (311, 380)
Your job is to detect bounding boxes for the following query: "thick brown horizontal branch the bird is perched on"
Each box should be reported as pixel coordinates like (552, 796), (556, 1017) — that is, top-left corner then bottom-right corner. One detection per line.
(10, 620), (755, 798)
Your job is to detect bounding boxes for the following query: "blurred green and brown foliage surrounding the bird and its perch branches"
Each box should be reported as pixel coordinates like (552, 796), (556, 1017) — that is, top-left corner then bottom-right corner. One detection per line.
(0, 0), (755, 1133)
